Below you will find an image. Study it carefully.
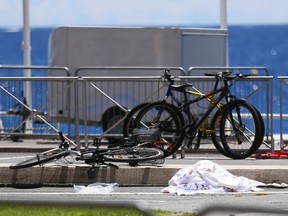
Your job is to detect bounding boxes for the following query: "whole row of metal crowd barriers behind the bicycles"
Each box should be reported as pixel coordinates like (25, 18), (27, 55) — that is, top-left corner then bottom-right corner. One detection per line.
(0, 66), (287, 154)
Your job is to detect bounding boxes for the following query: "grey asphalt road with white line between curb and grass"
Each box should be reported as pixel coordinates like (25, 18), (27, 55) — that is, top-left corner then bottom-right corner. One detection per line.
(0, 186), (288, 216)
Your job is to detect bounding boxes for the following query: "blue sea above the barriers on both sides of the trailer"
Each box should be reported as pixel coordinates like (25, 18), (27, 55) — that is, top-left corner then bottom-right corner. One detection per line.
(0, 25), (288, 134)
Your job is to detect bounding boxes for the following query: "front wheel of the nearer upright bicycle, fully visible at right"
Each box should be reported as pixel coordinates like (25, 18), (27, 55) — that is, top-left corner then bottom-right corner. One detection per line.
(220, 100), (264, 159)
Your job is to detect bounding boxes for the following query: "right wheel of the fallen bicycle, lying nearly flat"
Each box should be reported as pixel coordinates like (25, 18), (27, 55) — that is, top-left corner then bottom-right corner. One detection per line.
(103, 147), (164, 163)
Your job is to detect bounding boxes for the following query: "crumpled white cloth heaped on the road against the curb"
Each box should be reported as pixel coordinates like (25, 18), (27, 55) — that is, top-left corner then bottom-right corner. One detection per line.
(161, 160), (265, 195)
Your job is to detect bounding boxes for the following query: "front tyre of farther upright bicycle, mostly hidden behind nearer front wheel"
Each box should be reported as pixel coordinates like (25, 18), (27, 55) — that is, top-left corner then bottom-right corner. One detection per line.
(210, 104), (265, 157)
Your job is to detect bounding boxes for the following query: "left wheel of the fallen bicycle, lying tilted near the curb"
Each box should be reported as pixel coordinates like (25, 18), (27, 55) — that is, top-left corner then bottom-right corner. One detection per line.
(10, 148), (69, 169)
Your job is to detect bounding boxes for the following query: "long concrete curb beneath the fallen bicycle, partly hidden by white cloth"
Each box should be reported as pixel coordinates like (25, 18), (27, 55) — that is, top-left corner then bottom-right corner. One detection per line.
(0, 164), (288, 186)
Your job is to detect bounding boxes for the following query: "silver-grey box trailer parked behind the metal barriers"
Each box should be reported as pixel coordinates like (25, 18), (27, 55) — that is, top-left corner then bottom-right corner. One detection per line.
(48, 27), (228, 140)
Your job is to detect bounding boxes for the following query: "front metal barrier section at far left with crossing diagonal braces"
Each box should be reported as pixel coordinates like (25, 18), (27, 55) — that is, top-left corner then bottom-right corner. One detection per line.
(0, 77), (78, 139)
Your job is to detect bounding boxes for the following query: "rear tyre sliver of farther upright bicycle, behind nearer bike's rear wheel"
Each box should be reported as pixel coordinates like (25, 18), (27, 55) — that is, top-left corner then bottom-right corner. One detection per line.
(123, 102), (149, 138)
